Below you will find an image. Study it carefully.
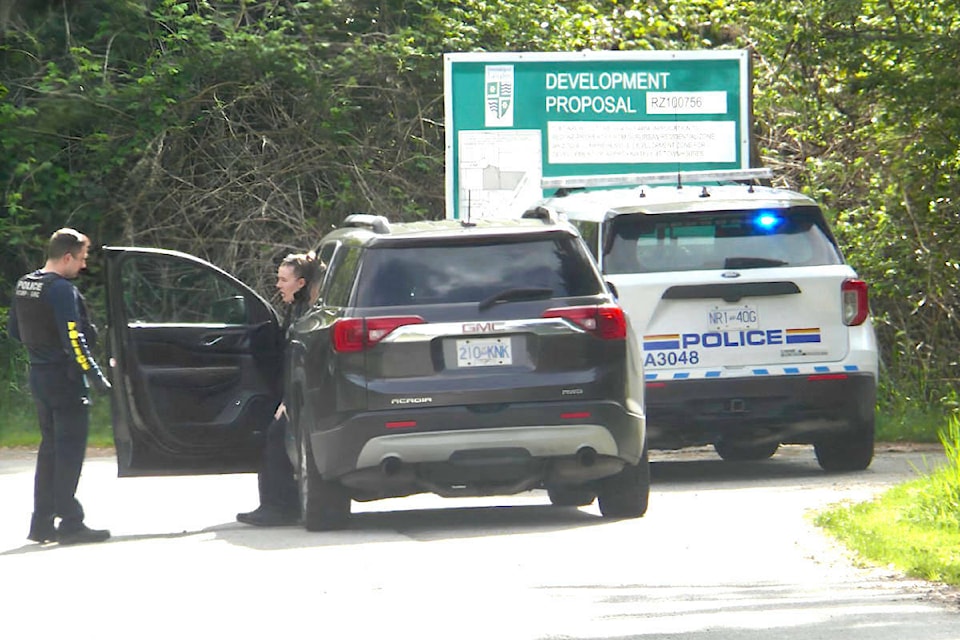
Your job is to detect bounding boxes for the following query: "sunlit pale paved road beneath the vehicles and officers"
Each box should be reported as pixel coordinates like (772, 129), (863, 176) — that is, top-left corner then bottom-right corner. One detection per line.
(0, 447), (960, 640)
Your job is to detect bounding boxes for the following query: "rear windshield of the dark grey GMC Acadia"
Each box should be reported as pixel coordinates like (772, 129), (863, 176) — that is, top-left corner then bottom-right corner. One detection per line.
(357, 234), (602, 307)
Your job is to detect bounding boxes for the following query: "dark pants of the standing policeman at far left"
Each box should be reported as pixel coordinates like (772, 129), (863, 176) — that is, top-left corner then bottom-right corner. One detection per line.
(30, 365), (90, 531)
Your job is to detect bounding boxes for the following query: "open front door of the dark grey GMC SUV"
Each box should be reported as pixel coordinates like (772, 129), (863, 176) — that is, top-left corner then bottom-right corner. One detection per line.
(103, 247), (283, 476)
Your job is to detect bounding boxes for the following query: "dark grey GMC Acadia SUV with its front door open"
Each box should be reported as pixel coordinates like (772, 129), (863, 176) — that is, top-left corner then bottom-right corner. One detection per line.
(105, 215), (650, 530)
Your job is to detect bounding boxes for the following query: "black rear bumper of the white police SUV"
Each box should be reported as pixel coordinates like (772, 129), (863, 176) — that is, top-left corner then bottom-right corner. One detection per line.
(645, 373), (876, 449)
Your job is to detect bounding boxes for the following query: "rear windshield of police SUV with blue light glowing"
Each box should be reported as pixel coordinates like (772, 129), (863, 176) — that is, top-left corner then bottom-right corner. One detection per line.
(603, 207), (843, 274)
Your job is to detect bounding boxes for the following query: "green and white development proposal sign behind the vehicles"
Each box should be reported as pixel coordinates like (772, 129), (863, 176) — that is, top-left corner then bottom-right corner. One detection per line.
(444, 50), (751, 219)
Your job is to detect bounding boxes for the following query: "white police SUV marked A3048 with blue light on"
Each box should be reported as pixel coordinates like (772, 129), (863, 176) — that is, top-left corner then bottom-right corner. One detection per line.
(528, 170), (878, 471)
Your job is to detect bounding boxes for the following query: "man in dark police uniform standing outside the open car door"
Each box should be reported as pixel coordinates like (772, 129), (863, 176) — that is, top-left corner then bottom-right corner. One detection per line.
(9, 229), (110, 544)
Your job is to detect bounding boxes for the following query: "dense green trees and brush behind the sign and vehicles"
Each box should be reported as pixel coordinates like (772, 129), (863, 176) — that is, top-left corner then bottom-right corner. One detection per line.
(0, 0), (960, 418)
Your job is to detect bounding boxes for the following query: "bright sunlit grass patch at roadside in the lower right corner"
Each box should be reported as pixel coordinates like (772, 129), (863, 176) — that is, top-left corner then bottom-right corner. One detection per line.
(815, 416), (960, 586)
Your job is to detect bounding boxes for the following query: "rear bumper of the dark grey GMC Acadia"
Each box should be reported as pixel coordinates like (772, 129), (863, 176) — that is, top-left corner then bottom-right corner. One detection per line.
(311, 402), (645, 500)
